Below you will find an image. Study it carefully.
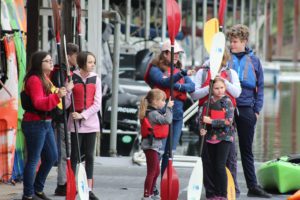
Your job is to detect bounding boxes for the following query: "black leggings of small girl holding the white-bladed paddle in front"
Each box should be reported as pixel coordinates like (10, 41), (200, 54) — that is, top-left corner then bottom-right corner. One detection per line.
(207, 141), (231, 197)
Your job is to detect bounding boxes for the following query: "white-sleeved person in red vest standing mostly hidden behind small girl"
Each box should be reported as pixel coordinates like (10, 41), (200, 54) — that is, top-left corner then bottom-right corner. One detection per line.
(191, 49), (242, 198)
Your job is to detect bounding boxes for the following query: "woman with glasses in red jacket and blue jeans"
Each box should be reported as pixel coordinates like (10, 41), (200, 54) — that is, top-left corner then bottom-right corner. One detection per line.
(21, 51), (73, 200)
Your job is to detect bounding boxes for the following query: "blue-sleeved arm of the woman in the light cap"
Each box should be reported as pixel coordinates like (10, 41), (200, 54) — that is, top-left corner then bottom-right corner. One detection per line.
(149, 66), (184, 88)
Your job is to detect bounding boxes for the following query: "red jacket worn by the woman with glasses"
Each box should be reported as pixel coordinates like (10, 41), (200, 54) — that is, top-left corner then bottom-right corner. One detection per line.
(23, 75), (59, 121)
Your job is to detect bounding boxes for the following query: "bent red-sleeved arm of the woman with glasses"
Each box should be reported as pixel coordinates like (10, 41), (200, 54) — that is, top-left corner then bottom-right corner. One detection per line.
(26, 76), (59, 111)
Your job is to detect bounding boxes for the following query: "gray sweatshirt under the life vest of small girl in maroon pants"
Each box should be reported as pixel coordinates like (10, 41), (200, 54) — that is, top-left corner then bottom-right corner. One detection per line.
(141, 107), (172, 152)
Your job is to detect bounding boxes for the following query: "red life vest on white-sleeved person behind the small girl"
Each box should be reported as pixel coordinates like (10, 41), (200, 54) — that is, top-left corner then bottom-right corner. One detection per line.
(199, 69), (236, 107)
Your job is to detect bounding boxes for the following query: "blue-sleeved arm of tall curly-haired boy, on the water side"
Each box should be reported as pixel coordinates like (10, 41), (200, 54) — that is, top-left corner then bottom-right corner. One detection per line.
(254, 58), (264, 115)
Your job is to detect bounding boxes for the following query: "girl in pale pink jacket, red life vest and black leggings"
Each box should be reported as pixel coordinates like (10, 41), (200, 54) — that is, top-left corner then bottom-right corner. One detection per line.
(66, 51), (102, 200)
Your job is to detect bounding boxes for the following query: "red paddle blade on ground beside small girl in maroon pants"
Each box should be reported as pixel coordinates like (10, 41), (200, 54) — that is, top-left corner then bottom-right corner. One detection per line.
(160, 160), (179, 200)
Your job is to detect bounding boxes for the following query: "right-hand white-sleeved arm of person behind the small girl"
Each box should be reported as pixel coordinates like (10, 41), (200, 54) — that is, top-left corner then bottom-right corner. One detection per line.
(225, 69), (242, 98)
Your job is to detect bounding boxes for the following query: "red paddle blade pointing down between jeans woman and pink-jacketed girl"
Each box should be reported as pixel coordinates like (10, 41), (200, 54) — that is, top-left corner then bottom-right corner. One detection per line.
(66, 159), (76, 200)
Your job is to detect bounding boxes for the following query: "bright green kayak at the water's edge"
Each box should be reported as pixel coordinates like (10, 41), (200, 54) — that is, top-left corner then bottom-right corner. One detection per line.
(257, 155), (300, 193)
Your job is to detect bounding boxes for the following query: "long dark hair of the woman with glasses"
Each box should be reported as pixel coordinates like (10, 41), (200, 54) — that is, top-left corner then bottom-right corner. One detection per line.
(24, 51), (52, 94)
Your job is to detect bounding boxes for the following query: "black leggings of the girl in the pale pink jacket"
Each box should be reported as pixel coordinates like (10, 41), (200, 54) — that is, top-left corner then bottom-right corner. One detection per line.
(71, 132), (96, 179)
